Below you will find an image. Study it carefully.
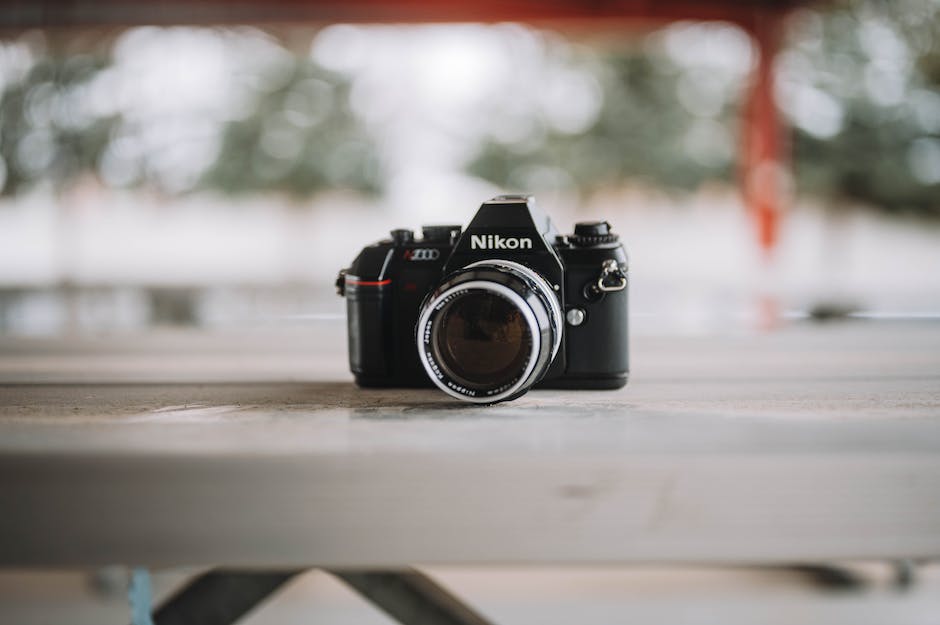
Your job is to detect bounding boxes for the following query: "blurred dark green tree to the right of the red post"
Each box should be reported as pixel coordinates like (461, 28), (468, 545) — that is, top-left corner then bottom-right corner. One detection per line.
(781, 0), (940, 217)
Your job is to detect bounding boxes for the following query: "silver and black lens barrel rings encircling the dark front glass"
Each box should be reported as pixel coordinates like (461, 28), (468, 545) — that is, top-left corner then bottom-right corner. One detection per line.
(415, 260), (562, 404)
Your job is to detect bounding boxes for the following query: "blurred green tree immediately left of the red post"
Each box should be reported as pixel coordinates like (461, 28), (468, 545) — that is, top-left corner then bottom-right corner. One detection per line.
(468, 46), (734, 192)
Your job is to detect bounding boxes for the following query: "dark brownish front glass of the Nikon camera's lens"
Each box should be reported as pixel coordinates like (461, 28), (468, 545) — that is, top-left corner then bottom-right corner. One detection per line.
(433, 290), (532, 389)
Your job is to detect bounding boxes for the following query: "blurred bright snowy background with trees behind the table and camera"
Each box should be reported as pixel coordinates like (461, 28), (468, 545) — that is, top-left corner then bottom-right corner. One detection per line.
(0, 0), (940, 335)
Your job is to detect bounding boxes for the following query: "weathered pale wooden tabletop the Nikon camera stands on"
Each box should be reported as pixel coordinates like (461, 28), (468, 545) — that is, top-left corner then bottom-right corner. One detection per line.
(0, 322), (940, 566)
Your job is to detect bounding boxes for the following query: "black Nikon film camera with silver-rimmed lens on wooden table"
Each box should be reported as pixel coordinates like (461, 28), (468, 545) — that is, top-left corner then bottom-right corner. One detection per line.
(336, 195), (629, 404)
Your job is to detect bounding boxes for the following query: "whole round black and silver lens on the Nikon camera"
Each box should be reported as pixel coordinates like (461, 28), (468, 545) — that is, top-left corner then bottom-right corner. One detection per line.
(417, 260), (562, 403)
